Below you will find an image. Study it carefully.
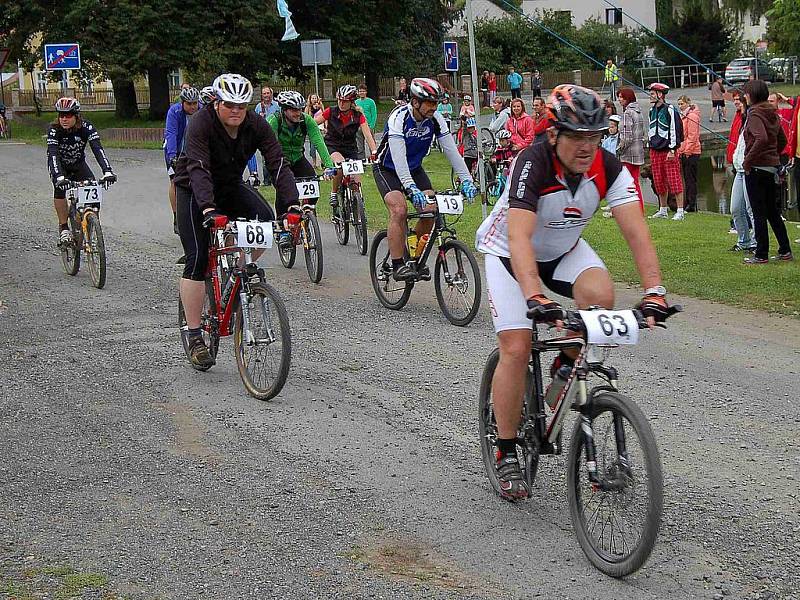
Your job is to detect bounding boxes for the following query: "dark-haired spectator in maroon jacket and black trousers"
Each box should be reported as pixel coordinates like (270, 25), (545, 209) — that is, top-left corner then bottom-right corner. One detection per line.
(743, 79), (793, 265)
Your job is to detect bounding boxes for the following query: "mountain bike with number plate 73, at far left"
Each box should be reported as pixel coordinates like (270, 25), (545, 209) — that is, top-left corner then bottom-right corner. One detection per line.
(59, 180), (111, 289)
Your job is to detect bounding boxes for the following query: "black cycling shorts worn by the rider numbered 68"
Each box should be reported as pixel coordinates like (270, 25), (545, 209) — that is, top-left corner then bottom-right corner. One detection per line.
(175, 182), (275, 281)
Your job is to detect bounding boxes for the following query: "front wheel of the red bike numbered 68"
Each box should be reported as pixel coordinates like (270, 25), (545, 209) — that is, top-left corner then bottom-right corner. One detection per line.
(233, 283), (292, 400)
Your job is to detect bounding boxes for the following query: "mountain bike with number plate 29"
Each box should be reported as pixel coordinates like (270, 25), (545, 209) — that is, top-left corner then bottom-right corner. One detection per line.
(274, 177), (323, 283)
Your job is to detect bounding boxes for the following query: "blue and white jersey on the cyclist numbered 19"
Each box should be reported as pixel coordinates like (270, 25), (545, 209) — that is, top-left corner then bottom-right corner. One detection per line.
(378, 104), (450, 171)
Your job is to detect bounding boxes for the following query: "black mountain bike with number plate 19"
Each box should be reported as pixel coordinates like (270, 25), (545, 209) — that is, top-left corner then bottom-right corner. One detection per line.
(369, 190), (481, 327)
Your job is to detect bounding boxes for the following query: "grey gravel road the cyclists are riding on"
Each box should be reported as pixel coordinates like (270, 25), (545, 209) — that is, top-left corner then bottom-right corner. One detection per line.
(0, 144), (800, 600)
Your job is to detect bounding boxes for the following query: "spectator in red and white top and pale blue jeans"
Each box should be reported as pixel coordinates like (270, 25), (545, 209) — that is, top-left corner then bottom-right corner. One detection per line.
(725, 90), (756, 254)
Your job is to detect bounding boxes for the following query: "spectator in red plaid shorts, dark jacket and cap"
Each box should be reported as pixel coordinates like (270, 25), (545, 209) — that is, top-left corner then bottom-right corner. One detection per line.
(647, 83), (686, 221)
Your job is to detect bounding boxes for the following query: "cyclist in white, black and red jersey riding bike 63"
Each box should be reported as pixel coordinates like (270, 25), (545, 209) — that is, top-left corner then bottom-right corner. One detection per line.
(476, 85), (669, 500)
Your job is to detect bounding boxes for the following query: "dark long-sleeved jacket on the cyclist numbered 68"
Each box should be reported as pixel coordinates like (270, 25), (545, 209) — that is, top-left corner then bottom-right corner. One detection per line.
(173, 104), (298, 213)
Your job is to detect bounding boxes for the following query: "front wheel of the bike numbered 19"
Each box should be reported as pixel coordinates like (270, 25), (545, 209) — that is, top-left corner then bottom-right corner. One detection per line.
(433, 239), (481, 327)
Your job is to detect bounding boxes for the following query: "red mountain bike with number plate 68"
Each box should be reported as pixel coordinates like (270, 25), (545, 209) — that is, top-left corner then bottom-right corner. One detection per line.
(178, 216), (292, 400)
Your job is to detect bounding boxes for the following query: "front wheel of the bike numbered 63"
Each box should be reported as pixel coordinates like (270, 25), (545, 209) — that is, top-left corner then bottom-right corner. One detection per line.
(567, 391), (664, 577)
